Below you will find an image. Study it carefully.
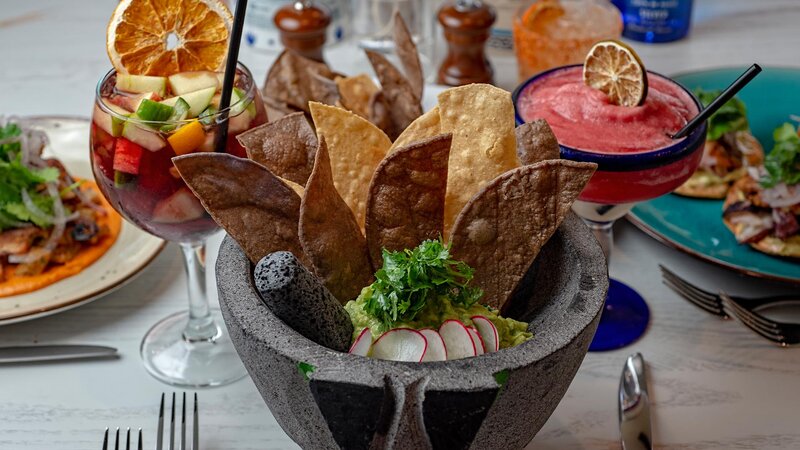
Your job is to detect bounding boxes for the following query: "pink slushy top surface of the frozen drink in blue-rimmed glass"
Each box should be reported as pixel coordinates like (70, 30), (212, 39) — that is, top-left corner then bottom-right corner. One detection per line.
(517, 66), (698, 153)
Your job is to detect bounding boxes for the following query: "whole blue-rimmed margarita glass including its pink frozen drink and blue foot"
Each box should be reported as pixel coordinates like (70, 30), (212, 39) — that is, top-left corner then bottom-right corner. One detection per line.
(513, 65), (706, 351)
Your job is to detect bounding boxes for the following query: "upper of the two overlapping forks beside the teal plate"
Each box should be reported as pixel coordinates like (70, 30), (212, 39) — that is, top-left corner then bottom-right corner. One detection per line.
(658, 264), (800, 319)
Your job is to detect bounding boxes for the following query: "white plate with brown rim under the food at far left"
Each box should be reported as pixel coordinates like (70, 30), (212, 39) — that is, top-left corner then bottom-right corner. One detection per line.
(0, 117), (166, 325)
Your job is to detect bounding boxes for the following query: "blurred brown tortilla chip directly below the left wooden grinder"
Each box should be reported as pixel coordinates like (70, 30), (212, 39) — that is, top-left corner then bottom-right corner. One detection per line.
(261, 50), (336, 112)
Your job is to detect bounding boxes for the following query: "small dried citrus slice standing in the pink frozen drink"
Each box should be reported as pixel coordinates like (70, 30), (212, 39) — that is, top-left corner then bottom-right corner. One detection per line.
(583, 40), (647, 106)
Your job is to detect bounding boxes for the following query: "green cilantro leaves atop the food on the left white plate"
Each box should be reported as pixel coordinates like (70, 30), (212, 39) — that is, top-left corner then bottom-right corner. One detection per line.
(0, 123), (59, 230)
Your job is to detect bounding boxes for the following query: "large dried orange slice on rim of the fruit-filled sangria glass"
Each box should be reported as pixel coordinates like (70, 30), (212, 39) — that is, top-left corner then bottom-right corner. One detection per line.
(106, 0), (233, 76)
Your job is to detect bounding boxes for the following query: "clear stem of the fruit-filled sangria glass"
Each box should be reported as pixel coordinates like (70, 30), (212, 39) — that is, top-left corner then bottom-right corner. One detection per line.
(180, 242), (219, 342)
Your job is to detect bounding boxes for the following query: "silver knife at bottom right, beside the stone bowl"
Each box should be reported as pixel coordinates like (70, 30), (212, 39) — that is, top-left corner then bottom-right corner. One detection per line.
(619, 353), (653, 450)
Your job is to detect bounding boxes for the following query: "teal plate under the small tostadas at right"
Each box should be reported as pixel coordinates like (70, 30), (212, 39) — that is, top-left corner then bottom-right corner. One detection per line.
(628, 67), (800, 284)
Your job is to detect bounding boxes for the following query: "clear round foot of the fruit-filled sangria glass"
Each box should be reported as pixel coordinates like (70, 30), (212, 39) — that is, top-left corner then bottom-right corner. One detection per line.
(140, 309), (247, 388)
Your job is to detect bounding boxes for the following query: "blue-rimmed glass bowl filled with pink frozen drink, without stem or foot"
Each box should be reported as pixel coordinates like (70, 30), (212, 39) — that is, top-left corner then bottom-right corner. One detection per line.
(514, 65), (706, 206)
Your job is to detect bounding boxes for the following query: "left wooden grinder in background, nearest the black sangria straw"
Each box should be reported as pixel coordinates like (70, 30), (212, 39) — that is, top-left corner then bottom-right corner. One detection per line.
(273, 0), (331, 62)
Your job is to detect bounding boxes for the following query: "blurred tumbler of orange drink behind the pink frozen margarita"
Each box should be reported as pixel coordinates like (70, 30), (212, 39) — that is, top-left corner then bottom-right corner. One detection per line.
(512, 0), (622, 81)
